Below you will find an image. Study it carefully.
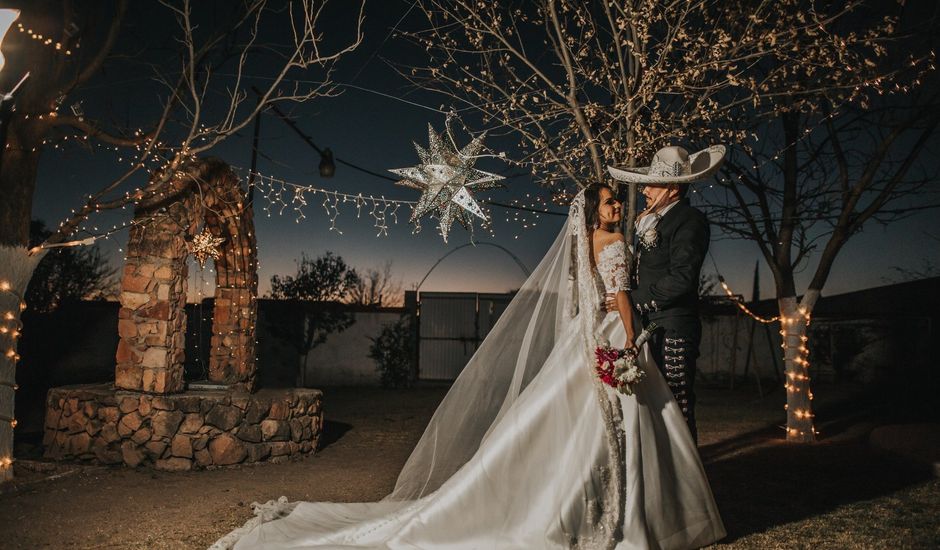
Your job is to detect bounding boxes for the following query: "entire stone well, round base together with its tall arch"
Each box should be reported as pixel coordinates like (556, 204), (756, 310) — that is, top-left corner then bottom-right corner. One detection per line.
(43, 159), (323, 470)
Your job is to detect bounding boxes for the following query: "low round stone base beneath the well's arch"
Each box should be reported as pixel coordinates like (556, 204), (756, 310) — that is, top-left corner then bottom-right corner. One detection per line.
(43, 384), (323, 471)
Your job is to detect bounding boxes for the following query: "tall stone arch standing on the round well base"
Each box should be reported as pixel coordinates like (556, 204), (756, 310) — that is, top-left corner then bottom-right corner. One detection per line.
(115, 158), (258, 394)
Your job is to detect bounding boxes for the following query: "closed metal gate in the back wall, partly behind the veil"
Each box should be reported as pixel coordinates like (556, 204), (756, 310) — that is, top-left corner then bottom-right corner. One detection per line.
(418, 292), (513, 380)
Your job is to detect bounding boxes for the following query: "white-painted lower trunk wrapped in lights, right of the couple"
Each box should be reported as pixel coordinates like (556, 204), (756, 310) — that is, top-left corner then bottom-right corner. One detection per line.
(777, 290), (819, 443)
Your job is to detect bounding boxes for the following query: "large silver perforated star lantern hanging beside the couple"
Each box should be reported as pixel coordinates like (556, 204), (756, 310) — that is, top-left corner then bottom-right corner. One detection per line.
(389, 115), (503, 243)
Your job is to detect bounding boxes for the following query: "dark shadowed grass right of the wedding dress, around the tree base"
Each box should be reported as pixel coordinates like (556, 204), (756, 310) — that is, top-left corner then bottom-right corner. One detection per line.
(699, 387), (940, 549)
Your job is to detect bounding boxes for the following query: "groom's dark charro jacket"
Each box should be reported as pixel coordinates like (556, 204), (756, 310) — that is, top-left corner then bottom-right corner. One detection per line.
(632, 199), (711, 321)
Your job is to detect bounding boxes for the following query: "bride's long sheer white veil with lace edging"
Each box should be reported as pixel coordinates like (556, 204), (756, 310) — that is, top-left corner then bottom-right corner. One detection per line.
(384, 192), (603, 500)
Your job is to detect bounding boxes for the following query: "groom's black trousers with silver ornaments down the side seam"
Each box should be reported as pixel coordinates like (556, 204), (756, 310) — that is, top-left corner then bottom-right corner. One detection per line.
(643, 316), (702, 443)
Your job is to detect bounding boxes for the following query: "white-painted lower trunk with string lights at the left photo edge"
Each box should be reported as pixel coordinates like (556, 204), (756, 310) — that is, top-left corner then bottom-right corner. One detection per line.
(0, 246), (45, 483)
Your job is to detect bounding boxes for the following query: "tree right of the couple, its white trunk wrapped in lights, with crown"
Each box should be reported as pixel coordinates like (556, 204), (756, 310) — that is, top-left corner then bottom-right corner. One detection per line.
(699, 2), (940, 442)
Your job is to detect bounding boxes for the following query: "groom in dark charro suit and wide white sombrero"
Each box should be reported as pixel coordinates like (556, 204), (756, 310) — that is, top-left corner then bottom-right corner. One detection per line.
(607, 145), (725, 442)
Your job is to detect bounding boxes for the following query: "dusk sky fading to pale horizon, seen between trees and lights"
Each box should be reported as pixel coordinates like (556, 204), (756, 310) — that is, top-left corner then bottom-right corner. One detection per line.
(27, 0), (940, 297)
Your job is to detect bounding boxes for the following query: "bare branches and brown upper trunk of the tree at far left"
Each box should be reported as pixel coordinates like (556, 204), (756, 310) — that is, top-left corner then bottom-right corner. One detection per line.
(0, 0), (363, 246)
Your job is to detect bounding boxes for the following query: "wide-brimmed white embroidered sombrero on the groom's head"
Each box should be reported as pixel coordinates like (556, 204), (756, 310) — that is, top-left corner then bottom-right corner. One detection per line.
(607, 145), (725, 186)
